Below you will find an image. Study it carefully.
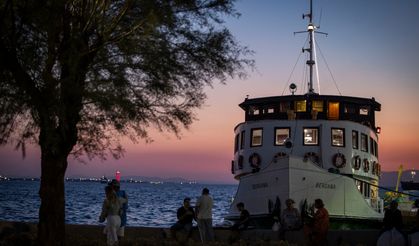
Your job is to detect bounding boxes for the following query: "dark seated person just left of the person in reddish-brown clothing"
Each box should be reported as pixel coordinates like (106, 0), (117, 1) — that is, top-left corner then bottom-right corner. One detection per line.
(280, 199), (301, 238)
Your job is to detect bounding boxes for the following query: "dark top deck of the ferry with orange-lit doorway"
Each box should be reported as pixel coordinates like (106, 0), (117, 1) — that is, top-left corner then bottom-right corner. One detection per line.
(239, 94), (381, 130)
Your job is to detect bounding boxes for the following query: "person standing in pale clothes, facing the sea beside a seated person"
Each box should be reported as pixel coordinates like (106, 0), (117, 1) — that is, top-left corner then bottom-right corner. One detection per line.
(195, 188), (214, 243)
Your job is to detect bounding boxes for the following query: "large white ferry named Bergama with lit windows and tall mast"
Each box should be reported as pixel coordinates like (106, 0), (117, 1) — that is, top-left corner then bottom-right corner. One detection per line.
(226, 2), (384, 227)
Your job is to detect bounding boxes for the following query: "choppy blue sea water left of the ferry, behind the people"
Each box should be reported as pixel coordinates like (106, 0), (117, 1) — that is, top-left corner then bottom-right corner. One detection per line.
(0, 180), (237, 227)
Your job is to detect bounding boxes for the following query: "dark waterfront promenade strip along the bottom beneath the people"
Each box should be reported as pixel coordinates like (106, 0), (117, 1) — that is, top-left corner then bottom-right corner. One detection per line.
(0, 221), (379, 246)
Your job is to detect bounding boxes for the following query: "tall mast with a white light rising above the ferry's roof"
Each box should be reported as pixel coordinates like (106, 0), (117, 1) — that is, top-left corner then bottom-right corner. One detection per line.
(294, 0), (327, 94)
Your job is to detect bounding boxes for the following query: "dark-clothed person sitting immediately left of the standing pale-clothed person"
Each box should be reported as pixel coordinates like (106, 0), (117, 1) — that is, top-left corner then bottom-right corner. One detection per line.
(170, 197), (196, 239)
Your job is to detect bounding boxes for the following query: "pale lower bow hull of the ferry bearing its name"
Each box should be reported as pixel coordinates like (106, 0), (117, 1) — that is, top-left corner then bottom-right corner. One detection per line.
(227, 156), (383, 227)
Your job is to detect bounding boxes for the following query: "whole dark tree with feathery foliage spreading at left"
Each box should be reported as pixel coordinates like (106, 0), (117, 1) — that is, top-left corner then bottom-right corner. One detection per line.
(0, 0), (253, 245)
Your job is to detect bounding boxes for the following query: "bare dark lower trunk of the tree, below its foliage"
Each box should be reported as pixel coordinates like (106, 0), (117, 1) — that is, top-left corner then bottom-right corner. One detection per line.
(38, 153), (67, 246)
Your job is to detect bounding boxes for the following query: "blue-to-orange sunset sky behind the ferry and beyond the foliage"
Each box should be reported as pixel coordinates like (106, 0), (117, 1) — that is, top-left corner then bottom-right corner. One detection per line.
(0, 0), (419, 183)
